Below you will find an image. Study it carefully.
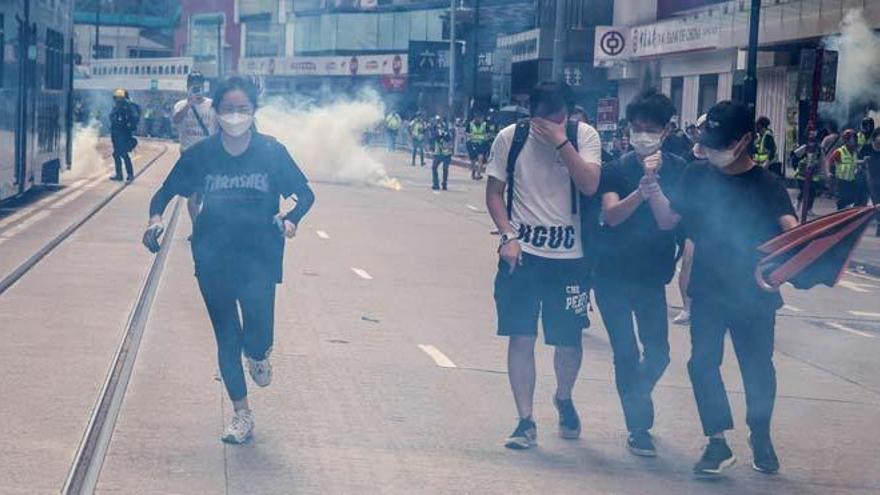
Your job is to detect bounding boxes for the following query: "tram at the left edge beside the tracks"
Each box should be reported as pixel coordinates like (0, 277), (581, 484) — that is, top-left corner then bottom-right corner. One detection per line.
(0, 0), (74, 201)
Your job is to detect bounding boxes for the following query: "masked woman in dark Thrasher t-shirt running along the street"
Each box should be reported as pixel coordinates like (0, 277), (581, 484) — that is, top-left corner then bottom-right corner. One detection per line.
(144, 77), (315, 443)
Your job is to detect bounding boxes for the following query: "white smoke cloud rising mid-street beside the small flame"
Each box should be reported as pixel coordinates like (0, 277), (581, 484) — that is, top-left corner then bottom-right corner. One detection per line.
(256, 94), (400, 189)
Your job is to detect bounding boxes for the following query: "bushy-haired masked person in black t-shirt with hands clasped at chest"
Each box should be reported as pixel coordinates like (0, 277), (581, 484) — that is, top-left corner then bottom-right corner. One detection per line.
(594, 90), (685, 457)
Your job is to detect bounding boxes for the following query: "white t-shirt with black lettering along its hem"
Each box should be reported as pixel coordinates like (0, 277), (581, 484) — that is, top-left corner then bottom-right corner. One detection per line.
(486, 123), (602, 259)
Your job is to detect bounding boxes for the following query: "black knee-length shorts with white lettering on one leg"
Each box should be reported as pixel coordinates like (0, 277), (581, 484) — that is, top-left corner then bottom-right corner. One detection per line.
(495, 253), (590, 347)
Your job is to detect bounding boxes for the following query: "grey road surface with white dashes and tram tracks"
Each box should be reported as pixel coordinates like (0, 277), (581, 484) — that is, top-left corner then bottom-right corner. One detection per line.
(0, 143), (880, 495)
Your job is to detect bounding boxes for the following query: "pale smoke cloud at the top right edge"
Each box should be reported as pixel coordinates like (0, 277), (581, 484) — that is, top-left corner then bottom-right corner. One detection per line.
(820, 10), (880, 125)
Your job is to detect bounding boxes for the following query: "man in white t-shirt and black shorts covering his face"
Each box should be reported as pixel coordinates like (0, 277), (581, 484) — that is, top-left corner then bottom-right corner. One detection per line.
(486, 82), (601, 449)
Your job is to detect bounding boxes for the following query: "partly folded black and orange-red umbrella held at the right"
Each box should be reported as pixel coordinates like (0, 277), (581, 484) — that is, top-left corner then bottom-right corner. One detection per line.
(755, 206), (880, 291)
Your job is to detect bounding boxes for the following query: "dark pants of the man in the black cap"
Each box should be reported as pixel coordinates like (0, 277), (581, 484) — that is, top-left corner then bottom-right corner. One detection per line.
(688, 298), (776, 436)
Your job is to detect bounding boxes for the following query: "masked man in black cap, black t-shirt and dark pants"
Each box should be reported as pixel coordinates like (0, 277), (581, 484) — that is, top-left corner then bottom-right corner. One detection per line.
(656, 101), (798, 477)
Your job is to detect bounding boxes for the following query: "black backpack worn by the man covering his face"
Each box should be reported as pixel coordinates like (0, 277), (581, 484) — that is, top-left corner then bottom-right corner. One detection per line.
(507, 119), (602, 268)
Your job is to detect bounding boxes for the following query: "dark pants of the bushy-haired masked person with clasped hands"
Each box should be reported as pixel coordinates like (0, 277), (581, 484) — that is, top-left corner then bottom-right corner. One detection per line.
(595, 280), (669, 432)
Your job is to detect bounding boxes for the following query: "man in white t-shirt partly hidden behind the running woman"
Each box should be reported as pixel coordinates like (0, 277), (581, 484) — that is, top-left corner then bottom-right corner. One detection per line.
(172, 72), (217, 229)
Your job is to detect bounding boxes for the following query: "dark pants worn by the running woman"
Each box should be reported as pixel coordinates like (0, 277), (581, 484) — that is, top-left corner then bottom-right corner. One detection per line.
(198, 277), (275, 401)
